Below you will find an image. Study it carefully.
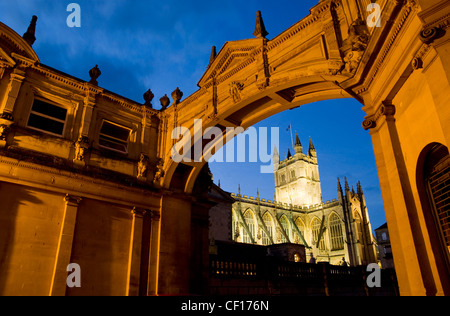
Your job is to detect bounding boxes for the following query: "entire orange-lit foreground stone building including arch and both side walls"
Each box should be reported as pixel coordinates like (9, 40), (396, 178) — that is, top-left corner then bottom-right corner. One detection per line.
(0, 0), (450, 295)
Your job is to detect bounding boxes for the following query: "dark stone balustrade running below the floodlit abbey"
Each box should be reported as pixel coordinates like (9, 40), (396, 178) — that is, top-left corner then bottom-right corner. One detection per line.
(210, 256), (398, 296)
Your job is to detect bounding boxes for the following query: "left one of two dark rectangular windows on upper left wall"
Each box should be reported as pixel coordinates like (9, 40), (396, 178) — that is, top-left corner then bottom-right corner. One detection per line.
(27, 99), (67, 136)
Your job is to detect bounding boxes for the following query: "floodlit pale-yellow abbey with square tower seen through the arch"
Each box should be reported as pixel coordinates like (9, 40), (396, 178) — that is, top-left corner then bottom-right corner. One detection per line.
(221, 135), (378, 266)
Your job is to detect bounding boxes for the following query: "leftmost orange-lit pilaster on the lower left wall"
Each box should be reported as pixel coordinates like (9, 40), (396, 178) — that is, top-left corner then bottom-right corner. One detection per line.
(50, 195), (81, 296)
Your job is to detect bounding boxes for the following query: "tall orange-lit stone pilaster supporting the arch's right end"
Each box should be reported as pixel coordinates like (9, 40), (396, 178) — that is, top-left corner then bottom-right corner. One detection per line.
(363, 102), (436, 295)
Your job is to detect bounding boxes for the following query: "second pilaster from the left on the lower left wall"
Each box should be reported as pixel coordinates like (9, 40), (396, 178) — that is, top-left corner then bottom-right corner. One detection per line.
(126, 208), (146, 296)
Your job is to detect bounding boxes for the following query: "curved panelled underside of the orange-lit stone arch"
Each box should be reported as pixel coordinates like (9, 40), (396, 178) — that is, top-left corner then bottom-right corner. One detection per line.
(164, 76), (352, 194)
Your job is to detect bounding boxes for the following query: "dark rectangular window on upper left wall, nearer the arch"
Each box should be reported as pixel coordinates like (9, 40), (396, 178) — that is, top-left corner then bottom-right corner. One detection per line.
(99, 121), (131, 153)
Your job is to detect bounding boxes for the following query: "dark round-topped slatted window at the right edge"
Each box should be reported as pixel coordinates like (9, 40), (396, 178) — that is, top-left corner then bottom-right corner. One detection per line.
(424, 145), (450, 255)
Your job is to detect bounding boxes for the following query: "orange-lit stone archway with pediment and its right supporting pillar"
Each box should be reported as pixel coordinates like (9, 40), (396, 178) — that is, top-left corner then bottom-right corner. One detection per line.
(159, 0), (450, 295)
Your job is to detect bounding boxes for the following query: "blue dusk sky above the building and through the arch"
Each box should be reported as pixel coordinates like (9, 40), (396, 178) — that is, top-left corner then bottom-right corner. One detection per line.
(0, 0), (386, 229)
